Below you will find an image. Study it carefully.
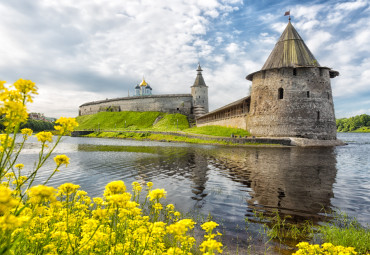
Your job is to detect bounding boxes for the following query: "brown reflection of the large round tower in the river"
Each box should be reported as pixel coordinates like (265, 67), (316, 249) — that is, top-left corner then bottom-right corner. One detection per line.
(210, 148), (337, 220)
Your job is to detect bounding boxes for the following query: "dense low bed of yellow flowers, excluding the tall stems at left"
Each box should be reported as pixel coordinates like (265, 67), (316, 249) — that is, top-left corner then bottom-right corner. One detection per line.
(0, 177), (222, 255)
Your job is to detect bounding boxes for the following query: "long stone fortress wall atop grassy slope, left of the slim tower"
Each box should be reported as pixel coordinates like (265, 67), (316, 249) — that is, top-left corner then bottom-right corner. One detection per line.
(79, 94), (192, 116)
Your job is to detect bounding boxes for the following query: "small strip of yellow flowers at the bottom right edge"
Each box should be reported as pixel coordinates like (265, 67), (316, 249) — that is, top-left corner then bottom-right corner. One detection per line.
(293, 242), (357, 255)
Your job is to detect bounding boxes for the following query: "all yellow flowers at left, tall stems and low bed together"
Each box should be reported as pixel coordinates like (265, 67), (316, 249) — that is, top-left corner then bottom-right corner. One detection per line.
(0, 79), (222, 255)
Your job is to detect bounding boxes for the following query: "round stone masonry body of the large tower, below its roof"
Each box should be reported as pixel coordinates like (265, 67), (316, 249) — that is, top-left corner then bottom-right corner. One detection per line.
(247, 67), (336, 140)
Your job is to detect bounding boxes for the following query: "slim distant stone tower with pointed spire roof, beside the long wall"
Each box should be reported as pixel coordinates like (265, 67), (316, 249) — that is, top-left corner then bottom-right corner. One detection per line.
(191, 64), (209, 117)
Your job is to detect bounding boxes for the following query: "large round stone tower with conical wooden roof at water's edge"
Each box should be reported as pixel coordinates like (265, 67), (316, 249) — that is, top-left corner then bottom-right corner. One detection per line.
(247, 20), (339, 140)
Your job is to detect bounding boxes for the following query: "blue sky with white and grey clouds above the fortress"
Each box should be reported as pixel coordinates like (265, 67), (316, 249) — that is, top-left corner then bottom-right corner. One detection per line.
(0, 0), (370, 118)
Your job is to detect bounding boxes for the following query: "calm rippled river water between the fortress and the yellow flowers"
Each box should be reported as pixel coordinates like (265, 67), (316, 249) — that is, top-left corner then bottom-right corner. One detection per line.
(20, 133), (370, 254)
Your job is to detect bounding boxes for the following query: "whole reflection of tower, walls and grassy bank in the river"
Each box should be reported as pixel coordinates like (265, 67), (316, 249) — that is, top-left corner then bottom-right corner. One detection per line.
(78, 144), (337, 221)
